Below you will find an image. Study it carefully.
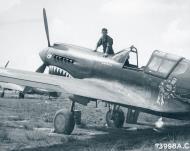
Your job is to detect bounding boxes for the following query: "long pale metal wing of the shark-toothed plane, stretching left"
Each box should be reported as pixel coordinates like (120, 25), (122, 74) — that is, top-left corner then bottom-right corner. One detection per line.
(0, 68), (186, 112)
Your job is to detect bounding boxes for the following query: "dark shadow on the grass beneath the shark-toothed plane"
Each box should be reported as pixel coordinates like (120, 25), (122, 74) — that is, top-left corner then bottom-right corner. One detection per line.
(15, 123), (190, 151)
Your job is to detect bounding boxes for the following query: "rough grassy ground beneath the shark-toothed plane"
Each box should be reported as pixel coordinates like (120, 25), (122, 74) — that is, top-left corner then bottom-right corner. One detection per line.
(0, 92), (190, 151)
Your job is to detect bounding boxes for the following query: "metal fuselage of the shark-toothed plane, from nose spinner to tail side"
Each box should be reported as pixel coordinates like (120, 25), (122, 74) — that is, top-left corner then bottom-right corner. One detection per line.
(40, 44), (190, 119)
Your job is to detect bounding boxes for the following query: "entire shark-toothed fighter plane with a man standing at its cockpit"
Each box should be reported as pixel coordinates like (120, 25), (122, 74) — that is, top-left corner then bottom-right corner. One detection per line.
(0, 9), (190, 134)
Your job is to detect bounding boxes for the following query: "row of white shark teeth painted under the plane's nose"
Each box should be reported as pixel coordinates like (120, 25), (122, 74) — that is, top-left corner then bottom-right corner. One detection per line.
(49, 66), (72, 78)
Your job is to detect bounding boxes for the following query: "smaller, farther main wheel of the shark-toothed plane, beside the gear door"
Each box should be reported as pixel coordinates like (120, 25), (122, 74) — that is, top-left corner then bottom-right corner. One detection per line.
(106, 109), (125, 128)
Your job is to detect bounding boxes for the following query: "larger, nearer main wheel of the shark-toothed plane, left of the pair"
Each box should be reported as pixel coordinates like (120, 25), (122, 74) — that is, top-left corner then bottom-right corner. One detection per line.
(53, 110), (75, 135)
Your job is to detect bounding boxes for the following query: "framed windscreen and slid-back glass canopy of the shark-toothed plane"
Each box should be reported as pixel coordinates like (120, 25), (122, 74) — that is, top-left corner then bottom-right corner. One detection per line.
(113, 49), (183, 78)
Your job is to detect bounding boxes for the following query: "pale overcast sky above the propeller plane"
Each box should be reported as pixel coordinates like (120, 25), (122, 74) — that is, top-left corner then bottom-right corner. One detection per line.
(0, 0), (190, 71)
